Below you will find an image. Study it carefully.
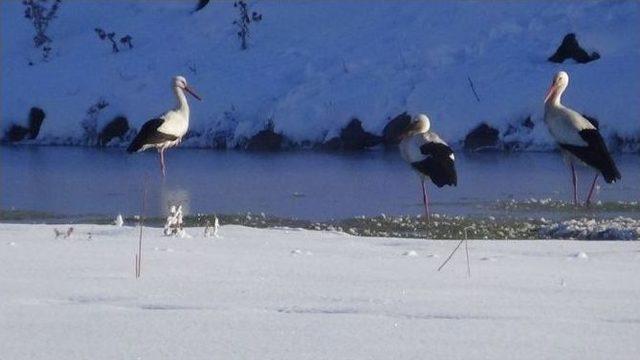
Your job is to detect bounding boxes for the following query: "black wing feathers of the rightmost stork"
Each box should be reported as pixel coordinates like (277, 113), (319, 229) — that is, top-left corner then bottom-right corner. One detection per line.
(559, 129), (621, 183)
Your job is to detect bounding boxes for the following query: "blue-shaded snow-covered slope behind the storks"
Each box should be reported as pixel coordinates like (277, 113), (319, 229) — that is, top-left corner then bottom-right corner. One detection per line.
(0, 0), (640, 149)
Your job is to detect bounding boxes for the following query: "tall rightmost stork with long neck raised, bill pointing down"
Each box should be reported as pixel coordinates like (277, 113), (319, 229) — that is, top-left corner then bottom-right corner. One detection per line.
(544, 71), (621, 206)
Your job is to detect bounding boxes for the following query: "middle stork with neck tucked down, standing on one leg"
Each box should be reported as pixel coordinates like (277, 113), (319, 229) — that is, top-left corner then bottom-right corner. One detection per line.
(399, 114), (458, 221)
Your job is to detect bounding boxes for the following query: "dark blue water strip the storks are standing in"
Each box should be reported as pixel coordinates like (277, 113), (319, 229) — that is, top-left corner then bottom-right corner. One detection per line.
(0, 146), (640, 220)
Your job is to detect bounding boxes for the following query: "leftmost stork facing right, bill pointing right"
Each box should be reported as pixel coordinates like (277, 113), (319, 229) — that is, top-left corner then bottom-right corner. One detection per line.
(127, 76), (202, 176)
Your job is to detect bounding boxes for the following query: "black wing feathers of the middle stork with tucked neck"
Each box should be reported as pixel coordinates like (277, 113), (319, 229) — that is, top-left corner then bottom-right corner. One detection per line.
(411, 142), (458, 187)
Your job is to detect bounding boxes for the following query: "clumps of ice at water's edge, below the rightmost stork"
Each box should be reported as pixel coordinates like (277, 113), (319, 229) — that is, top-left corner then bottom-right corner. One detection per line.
(539, 216), (640, 240)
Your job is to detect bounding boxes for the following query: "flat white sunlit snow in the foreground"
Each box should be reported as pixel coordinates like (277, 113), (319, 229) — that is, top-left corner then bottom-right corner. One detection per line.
(0, 224), (640, 359)
